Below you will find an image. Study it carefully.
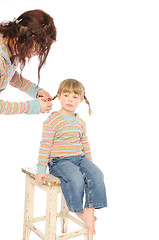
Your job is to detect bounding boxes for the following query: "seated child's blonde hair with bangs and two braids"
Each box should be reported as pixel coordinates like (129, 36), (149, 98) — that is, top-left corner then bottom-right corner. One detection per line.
(52, 78), (92, 115)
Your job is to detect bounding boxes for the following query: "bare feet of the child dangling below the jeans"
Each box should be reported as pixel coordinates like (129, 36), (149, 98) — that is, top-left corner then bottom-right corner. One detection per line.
(76, 208), (97, 235)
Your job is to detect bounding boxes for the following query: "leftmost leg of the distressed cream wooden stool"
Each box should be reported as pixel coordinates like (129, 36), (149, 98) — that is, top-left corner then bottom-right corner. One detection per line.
(23, 175), (35, 240)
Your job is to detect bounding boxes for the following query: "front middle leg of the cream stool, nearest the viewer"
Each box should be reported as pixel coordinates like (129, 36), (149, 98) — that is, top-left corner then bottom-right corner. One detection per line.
(45, 186), (58, 240)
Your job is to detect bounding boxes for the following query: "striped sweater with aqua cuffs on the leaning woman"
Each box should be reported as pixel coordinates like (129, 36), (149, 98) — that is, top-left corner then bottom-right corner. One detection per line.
(0, 34), (40, 115)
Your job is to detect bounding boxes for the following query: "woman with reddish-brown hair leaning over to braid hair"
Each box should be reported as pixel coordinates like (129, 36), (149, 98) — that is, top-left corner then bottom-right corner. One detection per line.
(0, 10), (56, 115)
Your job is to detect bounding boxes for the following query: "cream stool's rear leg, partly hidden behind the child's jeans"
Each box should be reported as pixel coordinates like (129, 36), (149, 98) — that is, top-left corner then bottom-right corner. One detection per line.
(61, 193), (69, 233)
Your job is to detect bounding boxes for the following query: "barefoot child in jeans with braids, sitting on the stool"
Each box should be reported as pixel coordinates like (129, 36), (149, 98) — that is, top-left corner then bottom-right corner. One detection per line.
(36, 79), (107, 234)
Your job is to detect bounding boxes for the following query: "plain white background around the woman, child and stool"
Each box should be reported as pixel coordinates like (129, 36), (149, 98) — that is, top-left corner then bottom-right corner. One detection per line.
(0, 0), (159, 240)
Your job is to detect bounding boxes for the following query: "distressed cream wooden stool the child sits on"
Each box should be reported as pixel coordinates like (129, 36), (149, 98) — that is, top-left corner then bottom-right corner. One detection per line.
(22, 168), (93, 240)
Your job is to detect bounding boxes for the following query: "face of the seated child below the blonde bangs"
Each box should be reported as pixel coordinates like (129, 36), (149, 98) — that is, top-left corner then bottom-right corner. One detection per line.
(58, 92), (83, 115)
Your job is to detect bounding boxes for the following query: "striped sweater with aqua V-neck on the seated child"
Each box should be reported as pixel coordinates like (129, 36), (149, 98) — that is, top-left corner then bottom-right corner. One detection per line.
(37, 112), (92, 173)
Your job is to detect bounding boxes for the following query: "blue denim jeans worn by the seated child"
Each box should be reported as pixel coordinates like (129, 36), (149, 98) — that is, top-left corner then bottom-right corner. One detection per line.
(48, 155), (107, 212)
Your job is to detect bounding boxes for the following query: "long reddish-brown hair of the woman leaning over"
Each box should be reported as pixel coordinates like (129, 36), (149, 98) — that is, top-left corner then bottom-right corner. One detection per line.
(0, 9), (56, 82)
